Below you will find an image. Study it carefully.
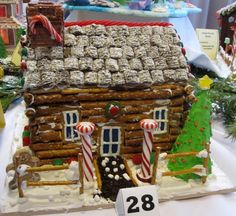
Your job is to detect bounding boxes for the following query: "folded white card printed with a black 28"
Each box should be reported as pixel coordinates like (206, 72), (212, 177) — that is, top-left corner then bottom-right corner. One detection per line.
(115, 186), (160, 216)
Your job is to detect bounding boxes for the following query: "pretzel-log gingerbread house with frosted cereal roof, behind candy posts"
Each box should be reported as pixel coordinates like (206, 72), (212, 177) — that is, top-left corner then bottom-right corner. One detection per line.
(24, 4), (192, 163)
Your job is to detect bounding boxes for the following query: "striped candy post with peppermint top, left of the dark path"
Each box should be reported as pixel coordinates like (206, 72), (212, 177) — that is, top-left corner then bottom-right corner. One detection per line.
(76, 122), (95, 182)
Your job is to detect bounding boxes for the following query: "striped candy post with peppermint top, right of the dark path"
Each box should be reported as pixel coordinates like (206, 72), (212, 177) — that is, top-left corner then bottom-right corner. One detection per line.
(137, 119), (158, 182)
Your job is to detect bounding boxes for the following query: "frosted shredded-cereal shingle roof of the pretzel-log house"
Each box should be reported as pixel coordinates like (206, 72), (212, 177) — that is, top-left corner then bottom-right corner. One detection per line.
(25, 24), (188, 89)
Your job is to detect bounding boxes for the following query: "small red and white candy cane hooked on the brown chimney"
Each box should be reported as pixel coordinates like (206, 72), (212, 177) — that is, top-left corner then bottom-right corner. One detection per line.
(29, 14), (62, 43)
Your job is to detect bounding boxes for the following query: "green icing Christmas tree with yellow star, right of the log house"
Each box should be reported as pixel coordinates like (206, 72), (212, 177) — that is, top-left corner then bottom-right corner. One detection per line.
(168, 75), (212, 181)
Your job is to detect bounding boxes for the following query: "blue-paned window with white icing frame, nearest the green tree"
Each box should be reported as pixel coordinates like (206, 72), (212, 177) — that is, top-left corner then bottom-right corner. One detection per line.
(153, 107), (168, 134)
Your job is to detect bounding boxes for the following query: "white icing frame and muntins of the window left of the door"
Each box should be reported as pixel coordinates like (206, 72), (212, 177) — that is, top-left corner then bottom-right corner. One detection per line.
(63, 110), (80, 141)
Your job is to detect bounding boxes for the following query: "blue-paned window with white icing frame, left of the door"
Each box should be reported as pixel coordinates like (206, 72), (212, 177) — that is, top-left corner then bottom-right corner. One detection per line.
(63, 110), (80, 141)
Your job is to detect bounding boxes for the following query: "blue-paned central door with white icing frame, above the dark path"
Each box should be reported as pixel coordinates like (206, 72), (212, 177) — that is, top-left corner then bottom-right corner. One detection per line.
(101, 126), (121, 156)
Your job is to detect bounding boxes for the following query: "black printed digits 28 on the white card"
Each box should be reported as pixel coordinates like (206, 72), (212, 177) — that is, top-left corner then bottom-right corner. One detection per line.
(126, 194), (155, 213)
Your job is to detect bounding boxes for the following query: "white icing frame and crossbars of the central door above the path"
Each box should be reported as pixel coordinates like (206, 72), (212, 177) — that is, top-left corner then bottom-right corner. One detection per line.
(100, 126), (121, 156)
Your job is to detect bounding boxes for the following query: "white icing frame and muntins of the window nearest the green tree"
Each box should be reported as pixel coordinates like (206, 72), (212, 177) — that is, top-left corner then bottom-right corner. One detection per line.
(153, 106), (169, 134)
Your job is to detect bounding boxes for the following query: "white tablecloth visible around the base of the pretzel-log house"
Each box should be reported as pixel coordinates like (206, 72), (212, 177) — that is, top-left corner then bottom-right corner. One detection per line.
(0, 105), (236, 216)
